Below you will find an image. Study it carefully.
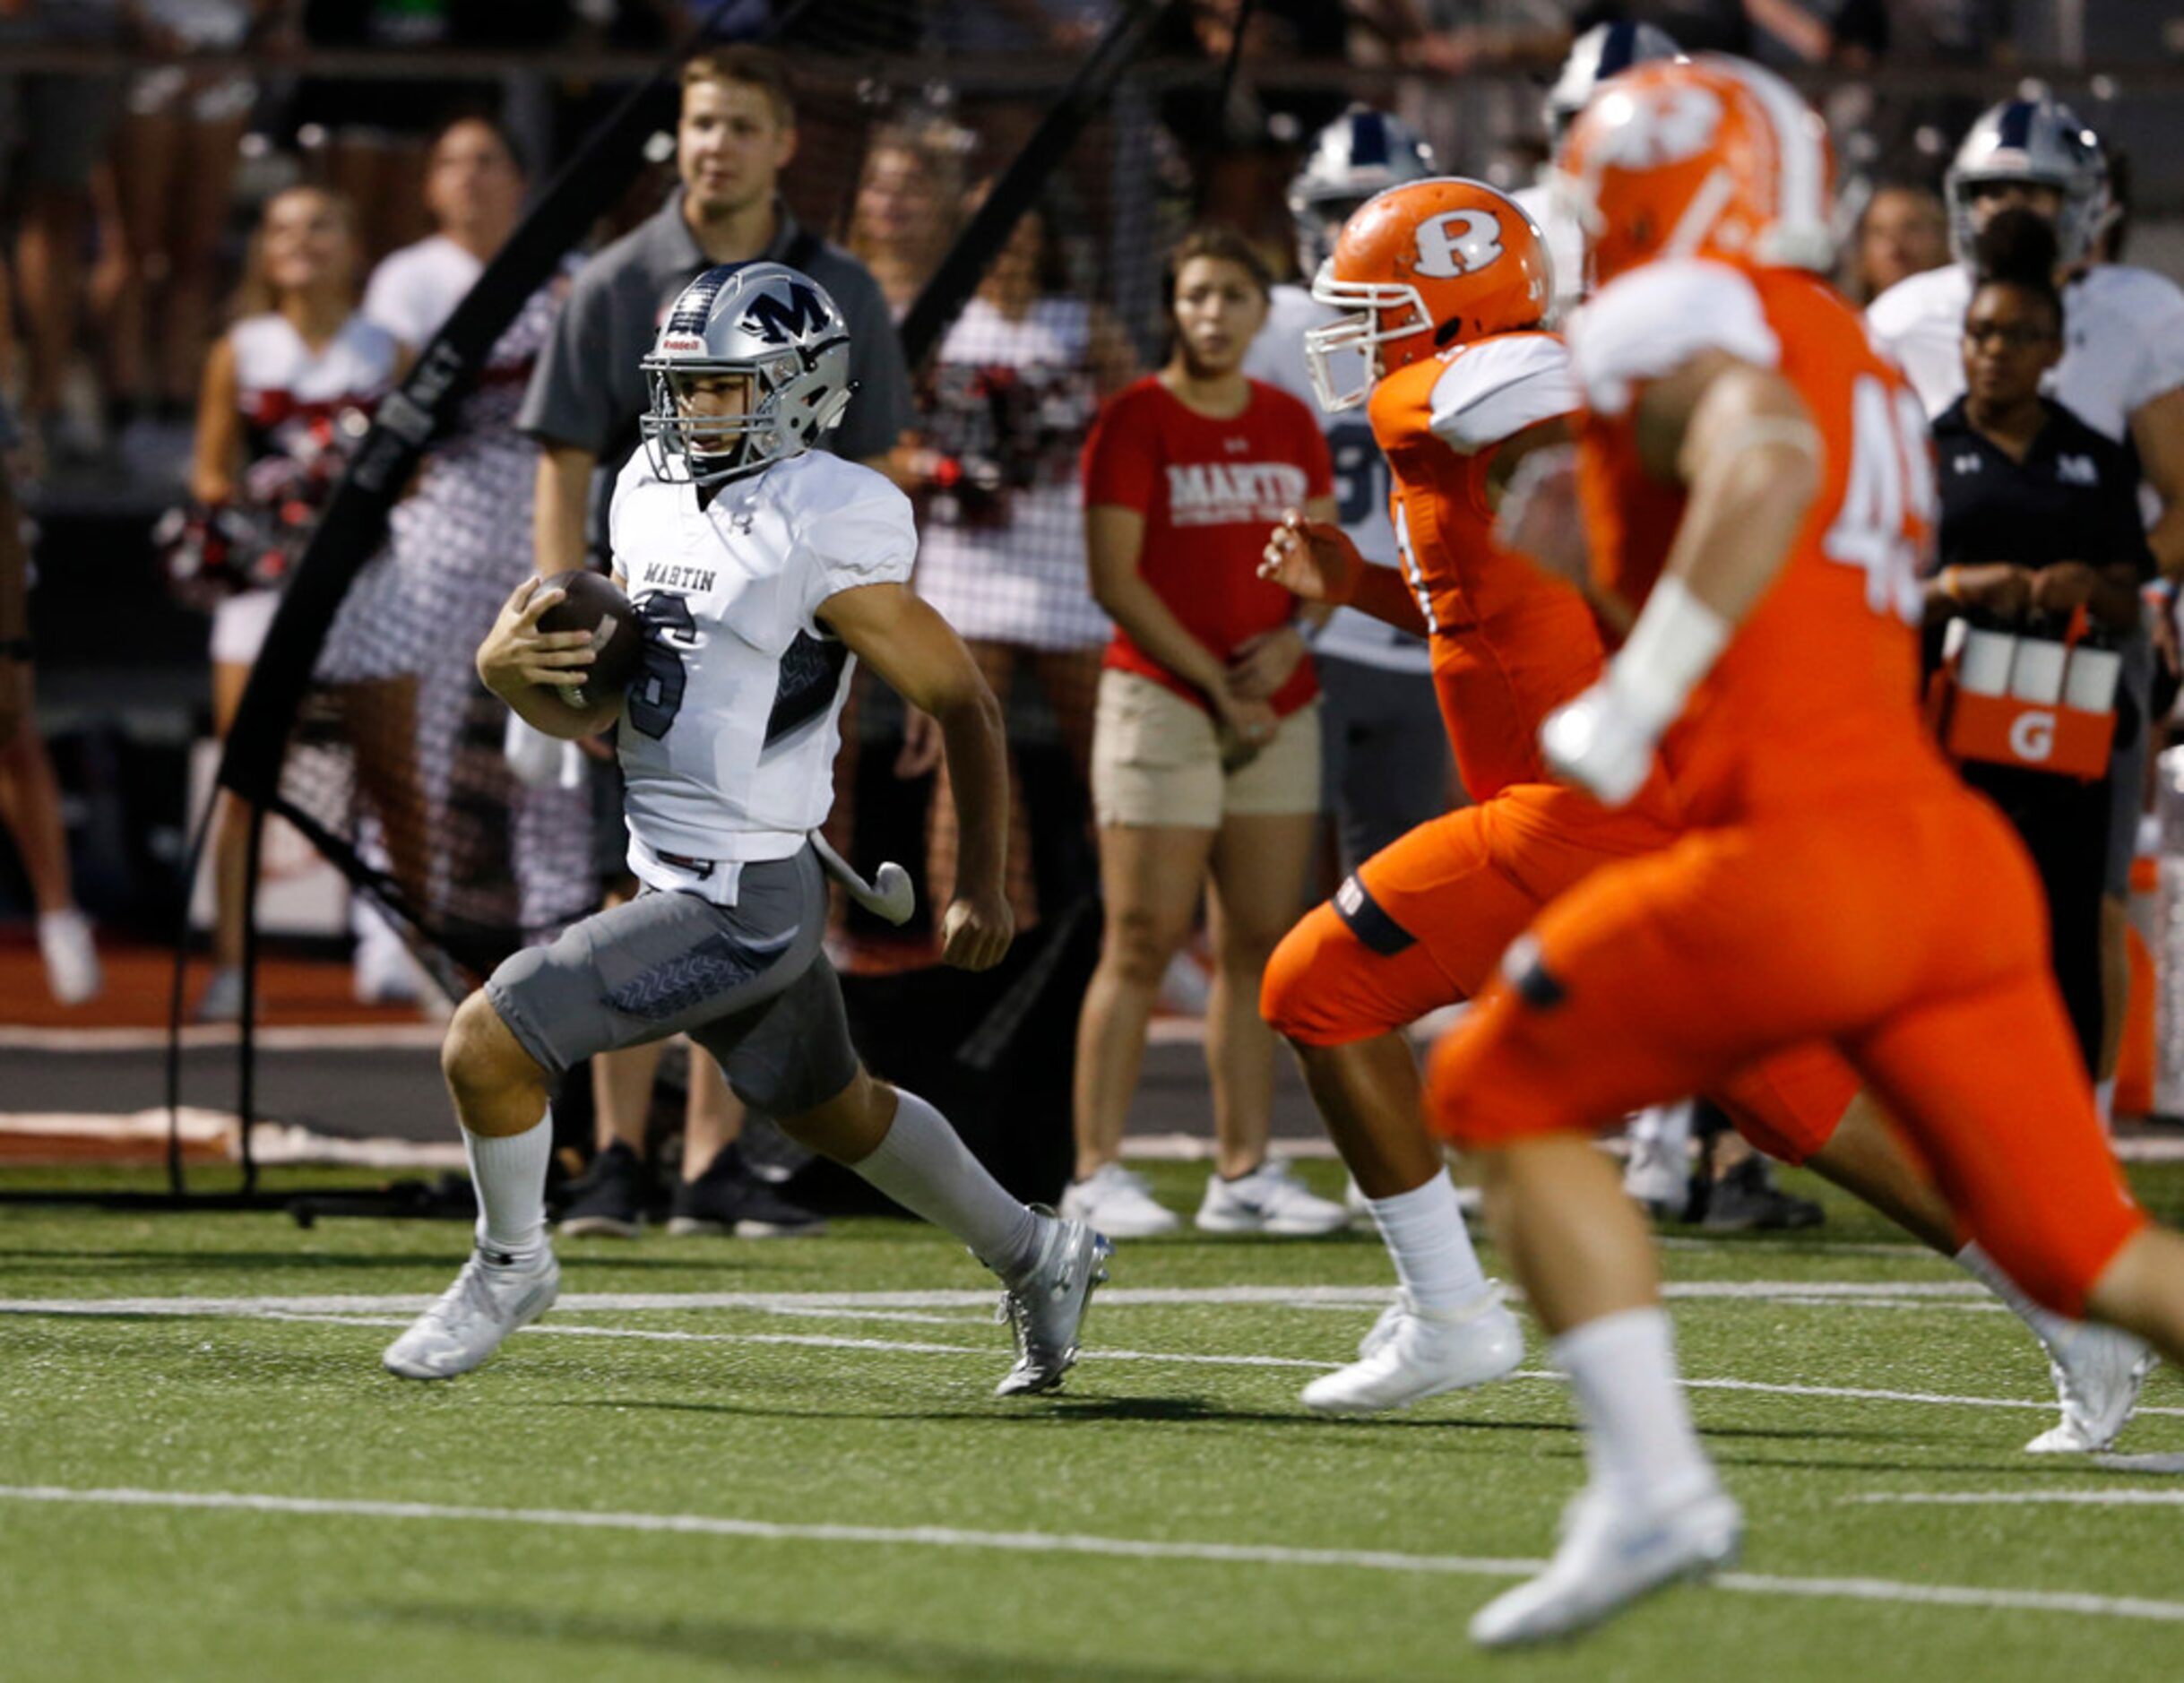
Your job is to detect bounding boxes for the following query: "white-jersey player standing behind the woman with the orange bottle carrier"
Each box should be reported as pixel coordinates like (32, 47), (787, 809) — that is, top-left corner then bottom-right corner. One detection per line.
(1865, 91), (2184, 1116)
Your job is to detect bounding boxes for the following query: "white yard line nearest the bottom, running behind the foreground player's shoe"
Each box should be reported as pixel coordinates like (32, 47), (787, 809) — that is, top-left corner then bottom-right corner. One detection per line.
(0, 1484), (2184, 1624)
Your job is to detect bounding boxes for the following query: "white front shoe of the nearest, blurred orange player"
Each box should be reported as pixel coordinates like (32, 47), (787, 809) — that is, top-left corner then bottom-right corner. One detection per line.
(1472, 1478), (1745, 1648)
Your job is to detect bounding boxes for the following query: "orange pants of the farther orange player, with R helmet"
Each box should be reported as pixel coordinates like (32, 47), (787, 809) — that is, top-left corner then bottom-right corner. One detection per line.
(1260, 783), (1859, 1163)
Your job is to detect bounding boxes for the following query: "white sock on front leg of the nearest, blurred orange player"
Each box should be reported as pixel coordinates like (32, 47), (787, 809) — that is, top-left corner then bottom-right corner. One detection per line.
(1553, 1308), (1714, 1499)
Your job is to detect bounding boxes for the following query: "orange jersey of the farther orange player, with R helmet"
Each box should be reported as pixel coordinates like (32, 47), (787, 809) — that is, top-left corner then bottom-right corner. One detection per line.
(1369, 332), (1603, 801)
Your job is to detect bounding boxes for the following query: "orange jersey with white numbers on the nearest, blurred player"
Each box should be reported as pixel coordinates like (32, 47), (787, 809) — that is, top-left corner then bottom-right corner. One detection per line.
(1570, 260), (1948, 821)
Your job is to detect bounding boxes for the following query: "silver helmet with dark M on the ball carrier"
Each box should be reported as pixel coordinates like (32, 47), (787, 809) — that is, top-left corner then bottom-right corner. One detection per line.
(640, 262), (856, 485)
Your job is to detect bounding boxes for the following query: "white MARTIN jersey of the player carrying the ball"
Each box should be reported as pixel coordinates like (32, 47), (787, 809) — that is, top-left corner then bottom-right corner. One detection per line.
(607, 450), (918, 886)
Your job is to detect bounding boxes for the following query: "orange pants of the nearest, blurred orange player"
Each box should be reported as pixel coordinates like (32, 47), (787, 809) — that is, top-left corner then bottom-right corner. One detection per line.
(1426, 786), (2147, 1314)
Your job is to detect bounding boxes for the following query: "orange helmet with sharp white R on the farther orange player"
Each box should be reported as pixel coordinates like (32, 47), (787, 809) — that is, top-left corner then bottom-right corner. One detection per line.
(1304, 175), (1555, 412)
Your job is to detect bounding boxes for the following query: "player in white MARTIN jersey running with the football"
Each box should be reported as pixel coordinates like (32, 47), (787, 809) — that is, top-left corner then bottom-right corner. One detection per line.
(384, 262), (1108, 1394)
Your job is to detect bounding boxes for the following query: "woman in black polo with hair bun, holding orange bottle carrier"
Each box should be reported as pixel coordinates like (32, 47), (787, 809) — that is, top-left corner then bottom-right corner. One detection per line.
(1926, 210), (2154, 1072)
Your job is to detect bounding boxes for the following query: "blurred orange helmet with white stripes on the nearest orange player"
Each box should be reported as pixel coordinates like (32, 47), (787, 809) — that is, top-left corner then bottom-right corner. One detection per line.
(1558, 52), (1834, 290)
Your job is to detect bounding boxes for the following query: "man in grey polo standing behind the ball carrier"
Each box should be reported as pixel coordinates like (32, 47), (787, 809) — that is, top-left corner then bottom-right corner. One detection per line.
(515, 46), (911, 1238)
